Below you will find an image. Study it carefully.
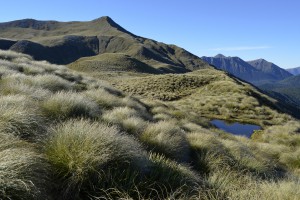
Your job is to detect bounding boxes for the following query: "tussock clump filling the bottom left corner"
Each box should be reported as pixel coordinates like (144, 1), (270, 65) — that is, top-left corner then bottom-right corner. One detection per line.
(0, 131), (49, 200)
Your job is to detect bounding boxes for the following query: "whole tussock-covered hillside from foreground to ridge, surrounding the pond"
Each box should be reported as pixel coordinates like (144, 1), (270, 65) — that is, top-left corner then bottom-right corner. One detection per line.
(0, 48), (300, 200)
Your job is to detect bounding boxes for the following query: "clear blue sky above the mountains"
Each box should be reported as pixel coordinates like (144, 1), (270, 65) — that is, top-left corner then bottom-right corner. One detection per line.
(0, 0), (300, 68)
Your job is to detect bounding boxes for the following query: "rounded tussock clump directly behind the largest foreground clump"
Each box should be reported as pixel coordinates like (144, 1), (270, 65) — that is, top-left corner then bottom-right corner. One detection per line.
(41, 92), (101, 120)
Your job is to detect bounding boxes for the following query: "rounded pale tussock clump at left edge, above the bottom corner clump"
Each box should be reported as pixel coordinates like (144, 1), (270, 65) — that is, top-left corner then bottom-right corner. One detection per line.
(0, 95), (45, 138)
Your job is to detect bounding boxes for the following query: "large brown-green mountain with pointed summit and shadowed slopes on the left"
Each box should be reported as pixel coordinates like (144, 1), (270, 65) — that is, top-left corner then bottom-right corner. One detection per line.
(0, 17), (208, 73)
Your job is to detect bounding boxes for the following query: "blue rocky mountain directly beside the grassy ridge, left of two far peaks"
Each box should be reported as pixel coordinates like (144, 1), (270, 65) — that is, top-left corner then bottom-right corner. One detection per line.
(201, 54), (278, 85)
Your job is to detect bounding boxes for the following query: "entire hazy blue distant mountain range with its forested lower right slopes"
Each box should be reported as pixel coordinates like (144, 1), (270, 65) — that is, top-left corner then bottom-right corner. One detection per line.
(202, 54), (300, 107)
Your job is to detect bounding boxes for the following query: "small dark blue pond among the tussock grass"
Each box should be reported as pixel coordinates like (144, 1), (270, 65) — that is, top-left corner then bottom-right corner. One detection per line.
(210, 119), (261, 138)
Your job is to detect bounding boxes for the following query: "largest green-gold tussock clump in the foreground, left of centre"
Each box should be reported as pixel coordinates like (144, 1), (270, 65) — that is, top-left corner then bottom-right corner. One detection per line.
(45, 120), (148, 199)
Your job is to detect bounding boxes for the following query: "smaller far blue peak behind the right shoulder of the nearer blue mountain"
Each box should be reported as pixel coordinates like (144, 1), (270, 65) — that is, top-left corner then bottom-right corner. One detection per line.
(247, 59), (292, 80)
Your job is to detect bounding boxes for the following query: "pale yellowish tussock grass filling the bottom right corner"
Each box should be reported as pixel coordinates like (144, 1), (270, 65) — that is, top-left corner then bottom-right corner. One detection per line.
(208, 170), (300, 200)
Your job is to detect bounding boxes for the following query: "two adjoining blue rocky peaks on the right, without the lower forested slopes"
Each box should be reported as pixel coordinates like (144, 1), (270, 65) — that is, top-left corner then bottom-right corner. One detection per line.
(202, 54), (293, 86)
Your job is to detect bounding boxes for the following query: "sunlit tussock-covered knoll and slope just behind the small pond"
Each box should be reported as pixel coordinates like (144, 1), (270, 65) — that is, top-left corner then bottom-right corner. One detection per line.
(114, 68), (296, 126)
